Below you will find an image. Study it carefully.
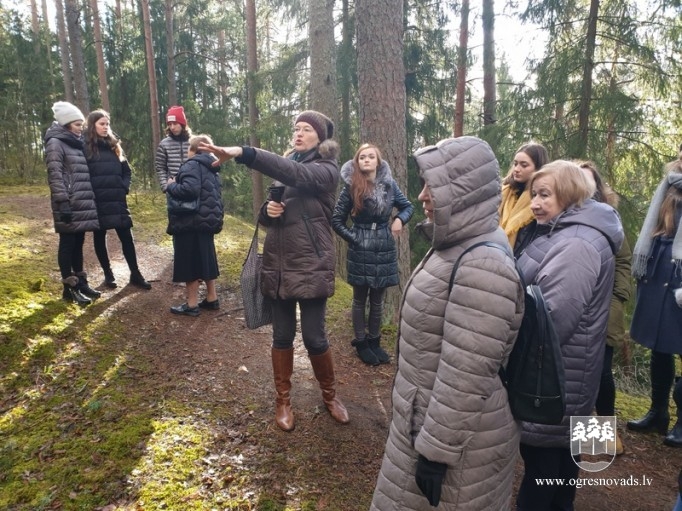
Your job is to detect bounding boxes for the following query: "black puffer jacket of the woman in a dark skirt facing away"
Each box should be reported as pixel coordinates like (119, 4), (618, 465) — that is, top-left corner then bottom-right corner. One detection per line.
(166, 153), (224, 234)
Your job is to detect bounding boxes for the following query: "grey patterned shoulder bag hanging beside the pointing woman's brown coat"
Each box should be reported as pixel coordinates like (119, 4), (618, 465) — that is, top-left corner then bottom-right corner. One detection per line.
(239, 223), (272, 330)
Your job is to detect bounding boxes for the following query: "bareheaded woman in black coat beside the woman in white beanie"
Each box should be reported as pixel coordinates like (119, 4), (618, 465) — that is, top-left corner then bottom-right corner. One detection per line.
(85, 110), (152, 289)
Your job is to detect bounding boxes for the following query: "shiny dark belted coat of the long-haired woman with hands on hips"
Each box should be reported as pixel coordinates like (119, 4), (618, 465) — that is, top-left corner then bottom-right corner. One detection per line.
(332, 160), (414, 288)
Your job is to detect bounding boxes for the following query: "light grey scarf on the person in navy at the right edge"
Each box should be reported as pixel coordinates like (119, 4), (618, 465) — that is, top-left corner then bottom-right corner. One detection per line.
(632, 172), (682, 279)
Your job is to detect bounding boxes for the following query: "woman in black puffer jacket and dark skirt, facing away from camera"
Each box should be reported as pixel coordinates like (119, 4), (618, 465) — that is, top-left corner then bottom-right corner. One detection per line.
(166, 135), (224, 316)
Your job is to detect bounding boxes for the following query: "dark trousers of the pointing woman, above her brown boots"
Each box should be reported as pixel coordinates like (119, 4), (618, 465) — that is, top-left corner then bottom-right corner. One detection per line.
(272, 298), (329, 355)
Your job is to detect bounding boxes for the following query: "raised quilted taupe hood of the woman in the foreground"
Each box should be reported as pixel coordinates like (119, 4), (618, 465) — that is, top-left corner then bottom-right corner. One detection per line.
(414, 137), (501, 249)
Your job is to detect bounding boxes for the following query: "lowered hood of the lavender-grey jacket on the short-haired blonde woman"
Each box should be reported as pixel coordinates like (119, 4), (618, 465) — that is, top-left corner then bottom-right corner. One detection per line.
(538, 199), (624, 254)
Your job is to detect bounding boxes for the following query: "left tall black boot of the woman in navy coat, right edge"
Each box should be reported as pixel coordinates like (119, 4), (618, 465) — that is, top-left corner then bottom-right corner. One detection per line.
(627, 352), (675, 435)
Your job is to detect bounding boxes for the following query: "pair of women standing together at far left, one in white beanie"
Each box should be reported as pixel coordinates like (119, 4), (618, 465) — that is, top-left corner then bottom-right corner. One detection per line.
(45, 101), (151, 305)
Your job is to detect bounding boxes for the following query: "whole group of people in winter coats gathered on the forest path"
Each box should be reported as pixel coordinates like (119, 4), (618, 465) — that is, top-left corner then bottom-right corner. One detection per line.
(46, 99), (682, 511)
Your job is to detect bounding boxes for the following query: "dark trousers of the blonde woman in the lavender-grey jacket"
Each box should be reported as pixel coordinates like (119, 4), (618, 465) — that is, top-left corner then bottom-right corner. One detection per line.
(516, 443), (580, 511)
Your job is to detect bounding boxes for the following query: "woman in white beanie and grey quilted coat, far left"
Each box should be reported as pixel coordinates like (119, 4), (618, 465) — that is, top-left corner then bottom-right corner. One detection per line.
(45, 101), (100, 305)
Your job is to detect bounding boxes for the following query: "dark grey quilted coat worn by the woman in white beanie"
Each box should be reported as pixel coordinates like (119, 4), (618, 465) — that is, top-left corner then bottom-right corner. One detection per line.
(45, 122), (99, 234)
